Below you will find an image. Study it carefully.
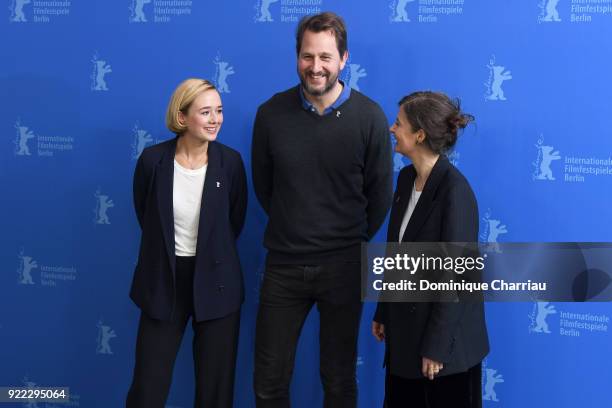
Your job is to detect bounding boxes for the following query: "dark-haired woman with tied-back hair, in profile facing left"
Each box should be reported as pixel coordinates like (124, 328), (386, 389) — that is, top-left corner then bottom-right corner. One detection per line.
(372, 92), (489, 408)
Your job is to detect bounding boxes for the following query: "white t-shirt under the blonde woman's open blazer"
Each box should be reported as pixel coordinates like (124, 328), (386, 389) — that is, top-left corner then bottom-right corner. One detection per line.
(172, 160), (208, 256)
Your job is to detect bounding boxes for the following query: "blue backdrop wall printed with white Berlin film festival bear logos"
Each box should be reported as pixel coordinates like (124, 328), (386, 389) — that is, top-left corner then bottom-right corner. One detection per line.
(0, 0), (612, 408)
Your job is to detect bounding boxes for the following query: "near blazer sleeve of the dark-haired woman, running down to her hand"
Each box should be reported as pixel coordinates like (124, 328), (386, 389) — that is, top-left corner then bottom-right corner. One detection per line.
(421, 182), (478, 363)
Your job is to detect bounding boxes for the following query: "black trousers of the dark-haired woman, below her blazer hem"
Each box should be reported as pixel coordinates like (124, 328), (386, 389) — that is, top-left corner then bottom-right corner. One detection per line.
(385, 364), (482, 408)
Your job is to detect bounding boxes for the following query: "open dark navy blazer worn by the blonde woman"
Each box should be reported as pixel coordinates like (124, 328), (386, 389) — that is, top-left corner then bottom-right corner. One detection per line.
(130, 138), (247, 321)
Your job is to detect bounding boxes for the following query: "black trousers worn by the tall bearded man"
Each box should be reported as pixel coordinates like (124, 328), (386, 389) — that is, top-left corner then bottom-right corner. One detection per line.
(254, 262), (362, 408)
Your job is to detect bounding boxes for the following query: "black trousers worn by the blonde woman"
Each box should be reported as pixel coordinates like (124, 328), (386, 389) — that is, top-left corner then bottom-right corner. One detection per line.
(126, 257), (240, 408)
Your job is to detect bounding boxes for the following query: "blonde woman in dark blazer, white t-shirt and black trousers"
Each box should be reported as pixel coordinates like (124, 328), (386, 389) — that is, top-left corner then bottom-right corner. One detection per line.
(127, 79), (247, 408)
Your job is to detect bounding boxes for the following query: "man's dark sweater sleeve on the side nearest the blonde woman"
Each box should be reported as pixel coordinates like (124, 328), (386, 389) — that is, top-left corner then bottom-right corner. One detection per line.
(251, 108), (272, 214)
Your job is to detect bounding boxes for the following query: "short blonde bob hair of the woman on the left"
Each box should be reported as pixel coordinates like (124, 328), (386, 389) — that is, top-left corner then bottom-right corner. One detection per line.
(166, 78), (217, 135)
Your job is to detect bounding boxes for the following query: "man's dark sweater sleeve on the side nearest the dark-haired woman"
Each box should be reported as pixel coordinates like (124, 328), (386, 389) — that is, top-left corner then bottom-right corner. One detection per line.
(364, 107), (393, 239)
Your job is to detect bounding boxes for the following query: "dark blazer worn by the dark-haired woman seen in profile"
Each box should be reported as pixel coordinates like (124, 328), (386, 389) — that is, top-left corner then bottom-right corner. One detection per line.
(374, 156), (489, 378)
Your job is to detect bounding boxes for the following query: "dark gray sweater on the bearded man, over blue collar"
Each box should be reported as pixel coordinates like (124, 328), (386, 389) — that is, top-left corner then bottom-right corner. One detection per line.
(252, 86), (393, 264)
